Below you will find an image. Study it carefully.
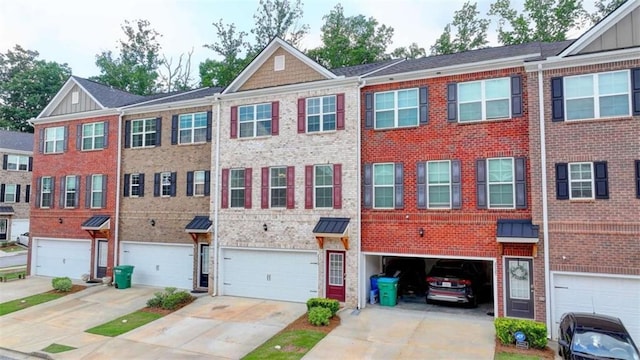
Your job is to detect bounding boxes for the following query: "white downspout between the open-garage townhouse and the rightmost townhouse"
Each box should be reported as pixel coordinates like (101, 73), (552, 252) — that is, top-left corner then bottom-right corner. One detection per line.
(538, 64), (552, 338)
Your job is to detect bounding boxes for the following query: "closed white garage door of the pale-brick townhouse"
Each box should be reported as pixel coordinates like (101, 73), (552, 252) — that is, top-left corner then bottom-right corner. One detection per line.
(221, 249), (318, 302)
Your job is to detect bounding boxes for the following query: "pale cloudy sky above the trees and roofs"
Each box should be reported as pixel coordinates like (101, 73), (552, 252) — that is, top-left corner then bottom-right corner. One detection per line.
(0, 0), (590, 78)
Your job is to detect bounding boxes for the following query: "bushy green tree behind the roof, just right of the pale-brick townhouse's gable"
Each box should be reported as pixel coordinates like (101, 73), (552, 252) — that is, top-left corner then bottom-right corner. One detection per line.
(307, 4), (393, 68)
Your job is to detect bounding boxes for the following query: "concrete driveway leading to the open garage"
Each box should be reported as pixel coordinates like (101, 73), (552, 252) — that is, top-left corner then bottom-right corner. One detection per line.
(303, 306), (495, 360)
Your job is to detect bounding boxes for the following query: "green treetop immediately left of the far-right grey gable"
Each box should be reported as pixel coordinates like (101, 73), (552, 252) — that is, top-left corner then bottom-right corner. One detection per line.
(489, 0), (587, 45)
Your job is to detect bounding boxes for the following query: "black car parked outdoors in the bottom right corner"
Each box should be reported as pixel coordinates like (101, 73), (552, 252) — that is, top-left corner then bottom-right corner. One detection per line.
(558, 313), (640, 360)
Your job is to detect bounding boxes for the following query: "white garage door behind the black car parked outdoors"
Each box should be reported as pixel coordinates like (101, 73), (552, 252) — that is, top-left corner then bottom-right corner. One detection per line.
(552, 273), (640, 343)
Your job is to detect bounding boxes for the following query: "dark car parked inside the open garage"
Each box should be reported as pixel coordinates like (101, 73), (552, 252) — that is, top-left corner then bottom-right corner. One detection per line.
(426, 259), (485, 307)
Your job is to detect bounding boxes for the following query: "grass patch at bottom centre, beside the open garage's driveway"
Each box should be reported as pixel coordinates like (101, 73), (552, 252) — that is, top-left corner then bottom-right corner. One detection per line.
(242, 330), (327, 360)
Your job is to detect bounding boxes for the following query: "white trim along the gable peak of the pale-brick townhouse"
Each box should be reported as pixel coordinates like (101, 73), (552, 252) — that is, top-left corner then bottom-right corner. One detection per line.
(223, 37), (338, 94)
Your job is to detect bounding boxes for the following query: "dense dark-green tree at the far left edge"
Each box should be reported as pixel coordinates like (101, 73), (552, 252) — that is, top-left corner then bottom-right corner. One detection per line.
(0, 45), (71, 132)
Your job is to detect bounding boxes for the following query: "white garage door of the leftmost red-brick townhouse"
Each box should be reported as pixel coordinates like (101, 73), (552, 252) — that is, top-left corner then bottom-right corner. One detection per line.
(31, 239), (91, 279)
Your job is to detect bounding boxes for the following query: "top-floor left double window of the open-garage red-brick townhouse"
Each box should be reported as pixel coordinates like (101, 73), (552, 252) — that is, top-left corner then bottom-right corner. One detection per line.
(375, 89), (418, 129)
